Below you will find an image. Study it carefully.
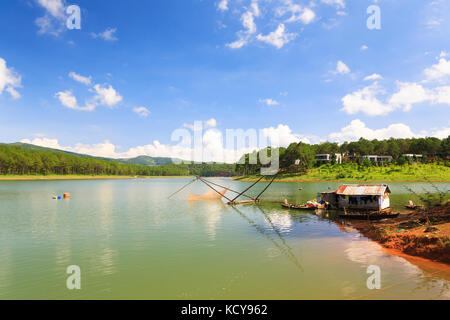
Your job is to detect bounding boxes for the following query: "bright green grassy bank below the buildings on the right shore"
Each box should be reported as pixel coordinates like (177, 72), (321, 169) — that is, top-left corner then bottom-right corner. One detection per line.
(235, 163), (450, 182)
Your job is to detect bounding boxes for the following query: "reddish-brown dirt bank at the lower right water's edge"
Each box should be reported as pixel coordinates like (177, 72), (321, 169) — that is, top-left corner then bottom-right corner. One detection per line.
(346, 204), (450, 264)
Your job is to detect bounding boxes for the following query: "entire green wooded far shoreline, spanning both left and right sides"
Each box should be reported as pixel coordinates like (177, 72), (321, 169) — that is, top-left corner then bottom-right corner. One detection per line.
(0, 137), (450, 182)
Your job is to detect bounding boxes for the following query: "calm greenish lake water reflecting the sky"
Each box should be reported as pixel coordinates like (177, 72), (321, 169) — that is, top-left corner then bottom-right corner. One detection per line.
(0, 178), (450, 299)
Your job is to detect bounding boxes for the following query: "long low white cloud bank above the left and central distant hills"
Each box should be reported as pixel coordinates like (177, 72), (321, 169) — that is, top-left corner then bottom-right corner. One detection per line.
(18, 119), (318, 163)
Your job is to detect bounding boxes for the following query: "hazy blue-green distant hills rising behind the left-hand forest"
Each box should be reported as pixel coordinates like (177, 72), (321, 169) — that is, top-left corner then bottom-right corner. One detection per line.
(7, 142), (183, 166)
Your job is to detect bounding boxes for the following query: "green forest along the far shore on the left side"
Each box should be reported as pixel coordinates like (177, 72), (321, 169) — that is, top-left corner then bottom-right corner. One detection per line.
(0, 145), (235, 177)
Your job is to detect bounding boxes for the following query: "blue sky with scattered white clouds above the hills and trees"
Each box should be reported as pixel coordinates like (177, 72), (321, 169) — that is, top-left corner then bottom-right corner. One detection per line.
(0, 0), (450, 160)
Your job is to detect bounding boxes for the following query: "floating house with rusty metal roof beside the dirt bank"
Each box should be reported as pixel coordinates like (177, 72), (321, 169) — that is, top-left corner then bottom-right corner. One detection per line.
(321, 184), (391, 211)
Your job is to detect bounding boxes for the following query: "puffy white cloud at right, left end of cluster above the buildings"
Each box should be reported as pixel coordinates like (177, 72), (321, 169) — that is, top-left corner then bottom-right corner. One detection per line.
(342, 82), (393, 116)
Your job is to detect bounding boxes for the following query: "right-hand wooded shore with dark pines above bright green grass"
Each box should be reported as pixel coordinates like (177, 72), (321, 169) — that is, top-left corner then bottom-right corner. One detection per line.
(235, 136), (450, 182)
